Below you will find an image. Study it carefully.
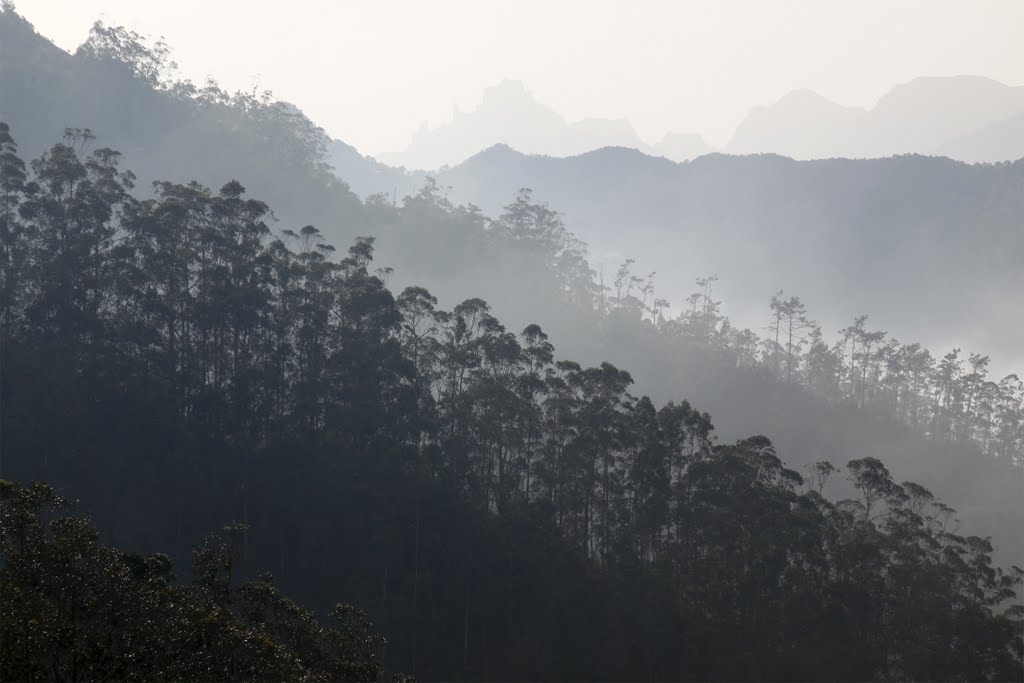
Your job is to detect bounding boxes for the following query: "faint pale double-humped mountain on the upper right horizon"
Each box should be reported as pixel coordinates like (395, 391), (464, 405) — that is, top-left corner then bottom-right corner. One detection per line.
(724, 76), (1024, 162)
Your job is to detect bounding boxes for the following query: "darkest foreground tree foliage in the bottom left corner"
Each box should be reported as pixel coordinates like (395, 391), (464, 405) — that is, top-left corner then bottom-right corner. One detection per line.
(0, 480), (407, 681)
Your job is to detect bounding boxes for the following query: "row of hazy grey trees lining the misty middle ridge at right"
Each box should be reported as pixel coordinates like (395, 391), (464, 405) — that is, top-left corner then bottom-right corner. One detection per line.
(598, 266), (1024, 467)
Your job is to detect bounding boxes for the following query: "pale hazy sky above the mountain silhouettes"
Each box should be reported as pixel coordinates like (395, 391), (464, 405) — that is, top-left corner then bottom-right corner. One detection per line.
(16, 0), (1024, 154)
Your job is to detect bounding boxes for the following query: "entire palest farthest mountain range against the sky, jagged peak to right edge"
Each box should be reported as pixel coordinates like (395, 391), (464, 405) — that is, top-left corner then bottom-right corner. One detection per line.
(379, 76), (1024, 169)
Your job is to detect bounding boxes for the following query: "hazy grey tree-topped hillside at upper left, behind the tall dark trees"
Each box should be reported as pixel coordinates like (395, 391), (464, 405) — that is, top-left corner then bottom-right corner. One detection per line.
(0, 11), (364, 224)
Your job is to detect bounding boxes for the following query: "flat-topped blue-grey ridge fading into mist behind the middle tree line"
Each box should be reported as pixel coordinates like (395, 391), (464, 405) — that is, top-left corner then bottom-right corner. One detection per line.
(439, 146), (1024, 372)
